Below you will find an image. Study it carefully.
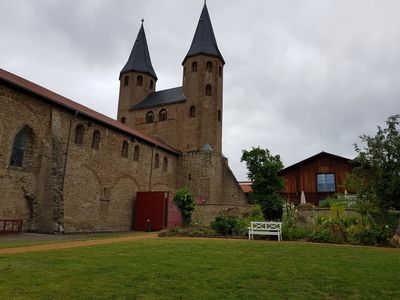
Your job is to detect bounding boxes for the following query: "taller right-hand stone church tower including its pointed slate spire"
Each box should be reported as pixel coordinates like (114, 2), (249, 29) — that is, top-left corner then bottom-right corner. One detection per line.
(182, 3), (225, 153)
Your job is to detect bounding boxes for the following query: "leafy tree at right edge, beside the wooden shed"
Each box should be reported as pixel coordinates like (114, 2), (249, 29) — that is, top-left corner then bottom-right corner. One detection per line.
(353, 115), (400, 210)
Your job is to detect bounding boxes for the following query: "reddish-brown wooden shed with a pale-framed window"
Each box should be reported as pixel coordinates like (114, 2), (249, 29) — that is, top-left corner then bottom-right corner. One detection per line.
(279, 152), (353, 205)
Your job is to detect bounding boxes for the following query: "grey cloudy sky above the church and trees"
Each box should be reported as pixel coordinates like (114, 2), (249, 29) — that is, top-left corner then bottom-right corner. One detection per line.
(0, 0), (400, 180)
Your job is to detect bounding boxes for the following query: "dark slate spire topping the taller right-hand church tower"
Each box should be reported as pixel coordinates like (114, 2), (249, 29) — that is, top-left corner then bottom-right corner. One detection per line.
(183, 2), (225, 64)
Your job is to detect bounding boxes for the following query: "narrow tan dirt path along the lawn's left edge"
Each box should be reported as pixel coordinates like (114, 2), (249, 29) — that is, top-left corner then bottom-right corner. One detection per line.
(0, 234), (158, 255)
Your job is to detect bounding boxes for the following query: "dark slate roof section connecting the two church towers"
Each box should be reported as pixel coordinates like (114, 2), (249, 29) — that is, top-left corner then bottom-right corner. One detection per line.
(130, 86), (186, 110)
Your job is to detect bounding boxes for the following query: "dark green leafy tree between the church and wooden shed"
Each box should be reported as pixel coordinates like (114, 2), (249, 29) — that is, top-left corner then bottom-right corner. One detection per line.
(240, 147), (283, 220)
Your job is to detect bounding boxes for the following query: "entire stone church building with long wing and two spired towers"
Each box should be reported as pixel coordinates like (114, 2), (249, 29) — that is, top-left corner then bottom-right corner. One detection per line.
(0, 4), (249, 233)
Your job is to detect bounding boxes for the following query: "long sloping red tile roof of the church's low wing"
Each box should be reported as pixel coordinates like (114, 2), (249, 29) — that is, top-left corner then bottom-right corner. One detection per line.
(0, 68), (181, 154)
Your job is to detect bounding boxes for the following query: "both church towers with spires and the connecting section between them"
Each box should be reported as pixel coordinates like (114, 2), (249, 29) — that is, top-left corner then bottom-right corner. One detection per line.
(118, 4), (225, 153)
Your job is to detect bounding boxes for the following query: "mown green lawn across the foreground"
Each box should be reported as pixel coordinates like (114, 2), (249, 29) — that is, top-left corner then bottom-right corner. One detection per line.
(0, 238), (400, 299)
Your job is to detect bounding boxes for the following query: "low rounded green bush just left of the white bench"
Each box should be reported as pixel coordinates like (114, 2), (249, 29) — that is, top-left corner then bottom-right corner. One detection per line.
(211, 215), (247, 236)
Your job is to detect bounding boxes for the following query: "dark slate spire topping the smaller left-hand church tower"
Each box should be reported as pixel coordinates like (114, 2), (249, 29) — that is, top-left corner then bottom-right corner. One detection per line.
(120, 19), (157, 79)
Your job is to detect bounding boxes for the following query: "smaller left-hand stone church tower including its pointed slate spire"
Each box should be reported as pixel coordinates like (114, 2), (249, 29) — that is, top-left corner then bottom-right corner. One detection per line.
(117, 20), (157, 126)
